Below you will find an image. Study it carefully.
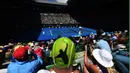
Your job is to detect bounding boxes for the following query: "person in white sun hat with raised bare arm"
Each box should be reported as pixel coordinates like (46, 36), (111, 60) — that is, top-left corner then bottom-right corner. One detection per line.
(83, 49), (118, 73)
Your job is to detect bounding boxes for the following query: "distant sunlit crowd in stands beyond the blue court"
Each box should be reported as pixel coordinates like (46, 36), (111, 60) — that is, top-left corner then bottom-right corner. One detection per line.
(40, 13), (78, 24)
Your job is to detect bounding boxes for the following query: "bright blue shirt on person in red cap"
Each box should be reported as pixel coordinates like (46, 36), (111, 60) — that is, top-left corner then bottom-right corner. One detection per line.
(8, 54), (43, 73)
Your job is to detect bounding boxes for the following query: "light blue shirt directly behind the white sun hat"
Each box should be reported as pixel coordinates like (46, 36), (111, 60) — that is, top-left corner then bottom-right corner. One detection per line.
(97, 39), (111, 53)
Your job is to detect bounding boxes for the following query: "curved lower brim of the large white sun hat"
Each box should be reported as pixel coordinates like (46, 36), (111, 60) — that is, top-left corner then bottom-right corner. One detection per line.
(92, 49), (114, 67)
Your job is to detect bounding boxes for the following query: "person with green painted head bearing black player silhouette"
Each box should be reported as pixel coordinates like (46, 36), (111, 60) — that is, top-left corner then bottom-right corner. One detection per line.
(38, 37), (79, 73)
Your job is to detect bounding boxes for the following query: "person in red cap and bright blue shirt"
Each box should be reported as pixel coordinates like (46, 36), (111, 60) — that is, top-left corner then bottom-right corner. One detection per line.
(8, 47), (43, 73)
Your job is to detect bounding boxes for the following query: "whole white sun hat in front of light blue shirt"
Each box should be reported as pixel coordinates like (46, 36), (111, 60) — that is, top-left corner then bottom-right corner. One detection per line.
(92, 49), (114, 67)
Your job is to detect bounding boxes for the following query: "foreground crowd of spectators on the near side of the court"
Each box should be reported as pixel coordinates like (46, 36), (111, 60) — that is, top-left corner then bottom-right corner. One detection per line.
(0, 30), (129, 73)
